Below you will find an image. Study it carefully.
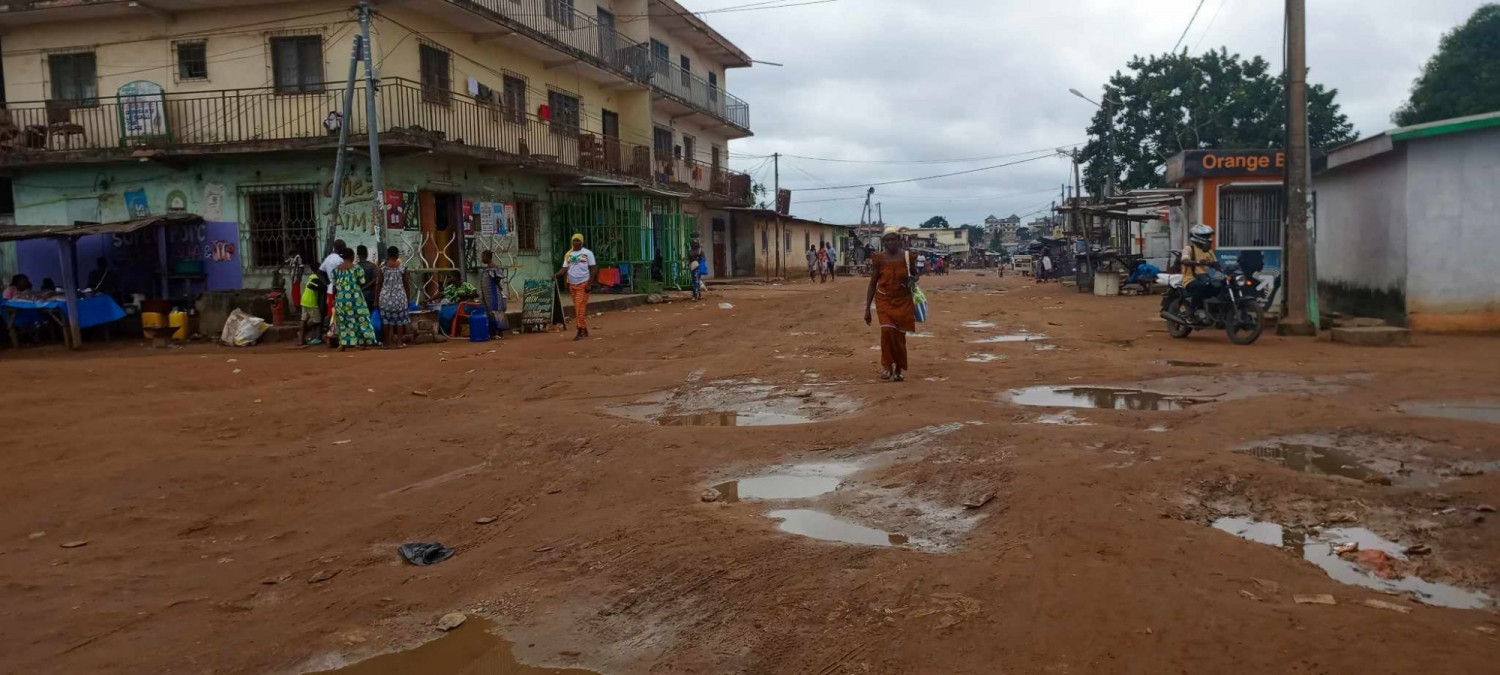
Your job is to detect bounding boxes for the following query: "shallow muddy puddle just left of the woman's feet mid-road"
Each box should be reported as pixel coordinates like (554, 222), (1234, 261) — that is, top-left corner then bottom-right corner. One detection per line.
(605, 380), (860, 426)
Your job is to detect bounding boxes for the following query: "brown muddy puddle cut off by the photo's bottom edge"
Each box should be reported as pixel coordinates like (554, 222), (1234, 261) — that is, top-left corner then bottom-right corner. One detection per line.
(317, 617), (599, 675)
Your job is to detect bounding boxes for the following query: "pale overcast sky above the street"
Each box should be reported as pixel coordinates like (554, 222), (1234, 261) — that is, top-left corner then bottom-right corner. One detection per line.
(684, 0), (1484, 225)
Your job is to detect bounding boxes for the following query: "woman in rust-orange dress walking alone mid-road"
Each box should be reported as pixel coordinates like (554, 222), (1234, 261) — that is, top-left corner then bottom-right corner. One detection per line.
(864, 233), (917, 383)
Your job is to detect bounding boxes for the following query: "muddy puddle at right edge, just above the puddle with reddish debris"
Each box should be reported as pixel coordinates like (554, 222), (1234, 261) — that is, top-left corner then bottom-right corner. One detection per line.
(1236, 432), (1500, 488)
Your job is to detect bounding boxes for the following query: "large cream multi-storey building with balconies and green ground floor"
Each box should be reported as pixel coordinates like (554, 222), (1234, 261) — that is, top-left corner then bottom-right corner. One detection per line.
(0, 0), (752, 303)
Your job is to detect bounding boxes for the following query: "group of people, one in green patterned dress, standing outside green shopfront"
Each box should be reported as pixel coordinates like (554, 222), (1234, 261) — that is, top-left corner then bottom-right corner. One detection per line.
(300, 239), (411, 351)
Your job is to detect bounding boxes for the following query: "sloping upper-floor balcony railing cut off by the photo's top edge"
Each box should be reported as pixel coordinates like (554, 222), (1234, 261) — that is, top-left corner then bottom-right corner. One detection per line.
(447, 0), (651, 84)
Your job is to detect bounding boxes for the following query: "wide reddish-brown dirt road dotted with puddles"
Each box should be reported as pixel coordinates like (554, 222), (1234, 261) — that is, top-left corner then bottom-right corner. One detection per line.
(0, 272), (1500, 675)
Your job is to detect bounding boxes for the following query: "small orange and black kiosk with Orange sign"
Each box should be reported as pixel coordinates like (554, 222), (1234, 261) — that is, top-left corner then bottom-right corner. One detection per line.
(1167, 150), (1287, 308)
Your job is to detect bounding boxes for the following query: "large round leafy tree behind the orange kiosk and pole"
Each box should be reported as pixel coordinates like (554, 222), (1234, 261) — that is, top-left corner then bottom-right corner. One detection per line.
(1083, 50), (1359, 195)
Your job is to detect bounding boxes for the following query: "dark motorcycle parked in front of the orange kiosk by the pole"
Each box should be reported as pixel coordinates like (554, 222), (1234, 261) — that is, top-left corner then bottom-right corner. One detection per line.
(1157, 263), (1266, 345)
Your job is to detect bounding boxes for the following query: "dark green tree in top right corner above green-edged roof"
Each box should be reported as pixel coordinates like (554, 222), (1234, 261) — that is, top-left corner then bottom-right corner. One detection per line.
(1391, 3), (1500, 126)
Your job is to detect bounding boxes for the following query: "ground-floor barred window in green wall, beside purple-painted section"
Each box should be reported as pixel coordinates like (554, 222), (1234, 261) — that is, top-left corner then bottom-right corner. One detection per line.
(240, 185), (318, 267)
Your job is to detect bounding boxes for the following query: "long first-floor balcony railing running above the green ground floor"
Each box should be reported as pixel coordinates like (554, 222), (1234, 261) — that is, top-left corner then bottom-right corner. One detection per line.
(0, 78), (749, 203)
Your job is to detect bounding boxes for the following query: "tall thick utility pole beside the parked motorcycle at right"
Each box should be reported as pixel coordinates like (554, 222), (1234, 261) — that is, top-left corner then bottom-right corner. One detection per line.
(1277, 0), (1317, 335)
